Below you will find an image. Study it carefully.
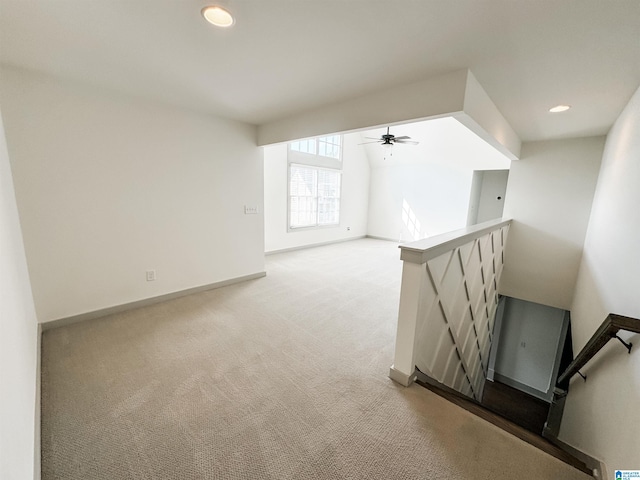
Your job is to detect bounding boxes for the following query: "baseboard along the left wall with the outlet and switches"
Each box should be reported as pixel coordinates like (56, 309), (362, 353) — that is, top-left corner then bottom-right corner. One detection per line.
(40, 272), (267, 331)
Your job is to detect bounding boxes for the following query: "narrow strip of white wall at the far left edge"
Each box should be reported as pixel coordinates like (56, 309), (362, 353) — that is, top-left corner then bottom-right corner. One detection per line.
(0, 107), (39, 480)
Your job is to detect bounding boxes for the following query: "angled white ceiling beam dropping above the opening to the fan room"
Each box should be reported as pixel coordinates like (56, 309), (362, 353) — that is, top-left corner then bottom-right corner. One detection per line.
(258, 70), (521, 160)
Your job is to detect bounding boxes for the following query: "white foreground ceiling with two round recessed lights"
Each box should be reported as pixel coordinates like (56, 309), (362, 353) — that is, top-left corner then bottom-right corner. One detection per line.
(0, 0), (640, 140)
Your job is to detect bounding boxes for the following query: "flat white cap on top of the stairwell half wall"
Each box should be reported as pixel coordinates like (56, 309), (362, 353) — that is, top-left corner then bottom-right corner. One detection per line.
(400, 219), (511, 264)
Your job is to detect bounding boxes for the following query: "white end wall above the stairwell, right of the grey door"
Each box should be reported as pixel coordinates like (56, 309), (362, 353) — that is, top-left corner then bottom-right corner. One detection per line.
(499, 137), (605, 310)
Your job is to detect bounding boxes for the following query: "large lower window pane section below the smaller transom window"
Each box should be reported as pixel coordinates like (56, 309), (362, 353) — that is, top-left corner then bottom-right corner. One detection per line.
(289, 164), (342, 228)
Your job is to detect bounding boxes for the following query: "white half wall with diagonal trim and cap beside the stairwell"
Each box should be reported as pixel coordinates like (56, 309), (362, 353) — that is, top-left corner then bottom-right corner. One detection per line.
(389, 219), (511, 400)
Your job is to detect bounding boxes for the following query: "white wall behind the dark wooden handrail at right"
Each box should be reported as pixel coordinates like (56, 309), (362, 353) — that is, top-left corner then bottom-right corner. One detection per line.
(560, 85), (640, 468)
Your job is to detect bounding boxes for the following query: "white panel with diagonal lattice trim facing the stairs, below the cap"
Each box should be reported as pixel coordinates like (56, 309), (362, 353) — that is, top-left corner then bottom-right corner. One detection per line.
(415, 225), (509, 400)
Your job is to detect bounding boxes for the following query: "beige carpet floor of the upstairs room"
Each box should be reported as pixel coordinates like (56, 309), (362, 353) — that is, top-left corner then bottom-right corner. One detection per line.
(42, 239), (590, 480)
